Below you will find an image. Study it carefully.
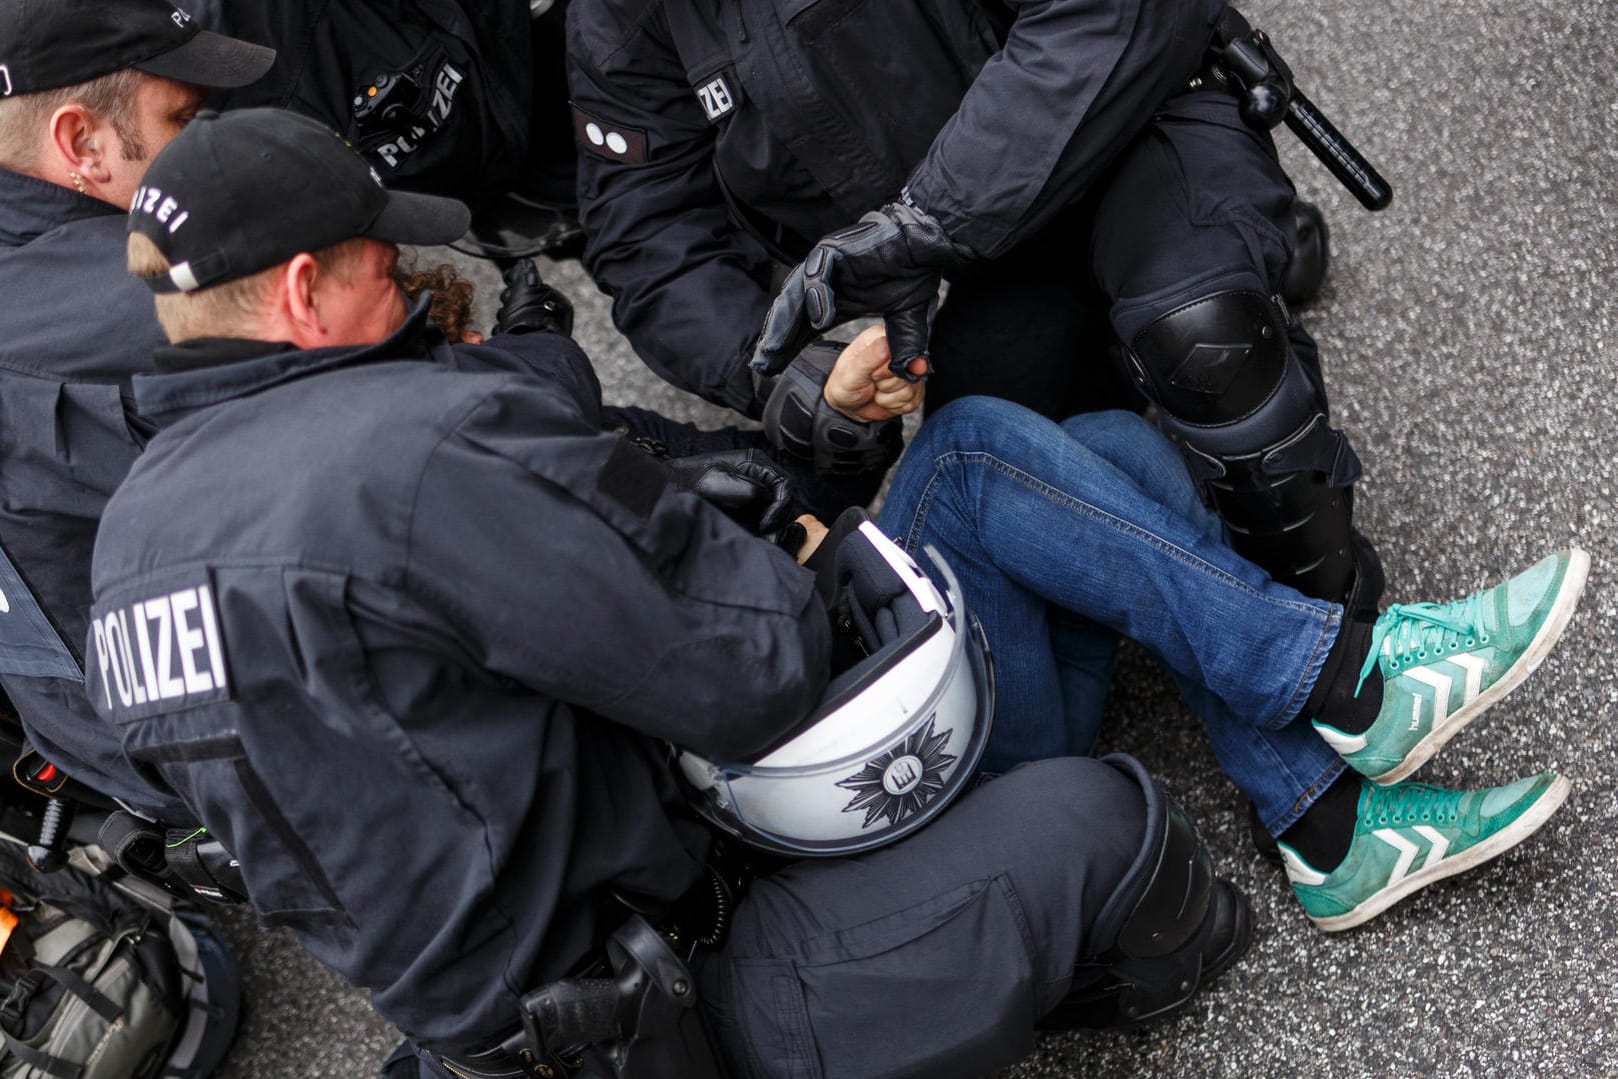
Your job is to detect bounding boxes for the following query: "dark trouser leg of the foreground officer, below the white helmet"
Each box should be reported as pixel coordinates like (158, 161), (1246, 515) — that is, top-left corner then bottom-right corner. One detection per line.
(699, 757), (1146, 1079)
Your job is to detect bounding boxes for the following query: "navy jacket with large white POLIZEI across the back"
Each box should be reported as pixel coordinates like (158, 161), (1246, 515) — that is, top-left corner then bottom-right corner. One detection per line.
(87, 307), (830, 1050)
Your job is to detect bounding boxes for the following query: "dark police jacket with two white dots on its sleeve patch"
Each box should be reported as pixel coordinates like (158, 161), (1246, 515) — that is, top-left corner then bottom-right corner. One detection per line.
(568, 0), (1225, 414)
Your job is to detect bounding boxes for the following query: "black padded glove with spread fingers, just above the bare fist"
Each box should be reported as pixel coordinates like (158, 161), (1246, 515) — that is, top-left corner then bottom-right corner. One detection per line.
(752, 202), (968, 380)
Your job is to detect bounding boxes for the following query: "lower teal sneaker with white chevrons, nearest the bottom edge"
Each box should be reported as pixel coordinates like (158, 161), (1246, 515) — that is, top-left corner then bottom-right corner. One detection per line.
(1280, 772), (1571, 933)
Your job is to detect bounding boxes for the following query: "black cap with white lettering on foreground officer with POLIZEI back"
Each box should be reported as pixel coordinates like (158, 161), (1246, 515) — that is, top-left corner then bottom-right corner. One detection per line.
(129, 108), (471, 293)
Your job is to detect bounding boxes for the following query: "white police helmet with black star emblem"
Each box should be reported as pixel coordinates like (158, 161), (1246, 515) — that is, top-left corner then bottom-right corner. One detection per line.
(676, 518), (995, 857)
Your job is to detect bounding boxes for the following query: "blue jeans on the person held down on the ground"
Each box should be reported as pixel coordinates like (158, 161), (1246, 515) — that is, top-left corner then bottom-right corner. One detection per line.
(882, 398), (1345, 833)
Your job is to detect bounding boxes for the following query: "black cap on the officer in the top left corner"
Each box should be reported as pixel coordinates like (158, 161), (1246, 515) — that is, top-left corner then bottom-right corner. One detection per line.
(0, 0), (275, 97)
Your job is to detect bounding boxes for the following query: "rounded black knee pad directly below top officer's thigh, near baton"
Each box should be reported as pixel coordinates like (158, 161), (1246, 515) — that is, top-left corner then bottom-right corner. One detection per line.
(1129, 290), (1288, 427)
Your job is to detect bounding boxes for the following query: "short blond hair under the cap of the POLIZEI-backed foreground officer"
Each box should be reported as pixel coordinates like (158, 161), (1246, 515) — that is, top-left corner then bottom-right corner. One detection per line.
(129, 233), (364, 343)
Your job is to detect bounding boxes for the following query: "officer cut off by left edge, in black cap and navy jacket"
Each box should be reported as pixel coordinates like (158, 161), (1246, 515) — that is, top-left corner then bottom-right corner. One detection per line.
(0, 0), (275, 809)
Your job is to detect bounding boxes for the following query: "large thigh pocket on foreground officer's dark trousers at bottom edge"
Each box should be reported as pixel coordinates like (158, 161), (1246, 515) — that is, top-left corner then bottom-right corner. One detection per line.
(731, 877), (1036, 1079)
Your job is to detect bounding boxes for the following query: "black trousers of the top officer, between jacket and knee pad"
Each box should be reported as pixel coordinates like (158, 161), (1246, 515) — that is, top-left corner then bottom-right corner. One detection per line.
(927, 91), (1324, 419)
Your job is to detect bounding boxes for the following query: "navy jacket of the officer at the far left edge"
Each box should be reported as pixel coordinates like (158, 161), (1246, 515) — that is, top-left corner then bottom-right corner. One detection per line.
(0, 170), (190, 812)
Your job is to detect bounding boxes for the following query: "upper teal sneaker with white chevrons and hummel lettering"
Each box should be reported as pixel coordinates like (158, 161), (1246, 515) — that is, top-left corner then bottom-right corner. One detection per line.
(1312, 550), (1590, 783)
